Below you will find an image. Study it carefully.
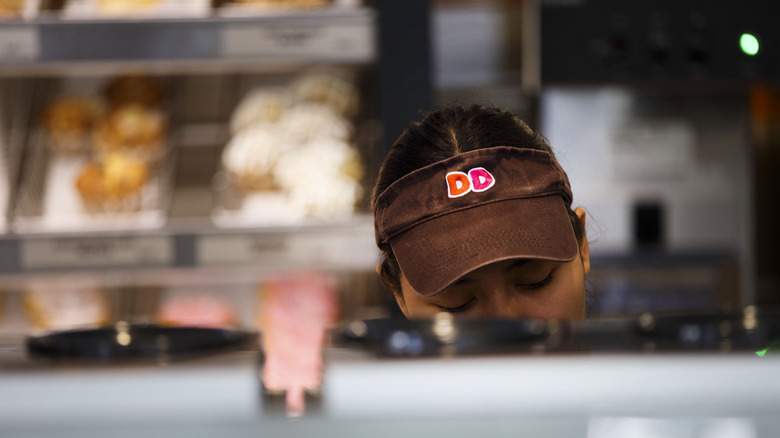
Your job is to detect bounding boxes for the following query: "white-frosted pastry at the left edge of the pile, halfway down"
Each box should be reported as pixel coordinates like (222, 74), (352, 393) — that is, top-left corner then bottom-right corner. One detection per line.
(222, 125), (289, 191)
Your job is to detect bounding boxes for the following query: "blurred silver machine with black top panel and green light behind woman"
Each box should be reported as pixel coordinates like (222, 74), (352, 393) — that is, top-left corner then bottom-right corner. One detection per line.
(539, 0), (778, 311)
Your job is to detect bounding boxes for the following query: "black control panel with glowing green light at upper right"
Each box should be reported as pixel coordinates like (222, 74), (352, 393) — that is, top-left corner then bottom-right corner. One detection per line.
(541, 0), (780, 86)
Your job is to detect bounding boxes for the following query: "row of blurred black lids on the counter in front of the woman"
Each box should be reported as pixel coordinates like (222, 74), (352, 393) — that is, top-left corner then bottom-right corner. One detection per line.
(340, 306), (780, 358)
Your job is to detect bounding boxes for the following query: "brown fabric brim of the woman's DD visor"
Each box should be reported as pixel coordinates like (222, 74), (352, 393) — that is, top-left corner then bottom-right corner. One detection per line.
(390, 194), (579, 296)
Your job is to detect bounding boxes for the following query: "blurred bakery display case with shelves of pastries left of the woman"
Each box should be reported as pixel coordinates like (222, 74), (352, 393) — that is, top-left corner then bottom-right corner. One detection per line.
(0, 0), (430, 336)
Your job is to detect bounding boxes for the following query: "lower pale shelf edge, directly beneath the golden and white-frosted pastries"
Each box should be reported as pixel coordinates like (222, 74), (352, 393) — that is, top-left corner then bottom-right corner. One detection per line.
(0, 215), (378, 275)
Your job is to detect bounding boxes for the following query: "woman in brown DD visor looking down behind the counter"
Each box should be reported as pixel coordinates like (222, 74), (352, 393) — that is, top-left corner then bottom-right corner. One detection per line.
(372, 106), (590, 319)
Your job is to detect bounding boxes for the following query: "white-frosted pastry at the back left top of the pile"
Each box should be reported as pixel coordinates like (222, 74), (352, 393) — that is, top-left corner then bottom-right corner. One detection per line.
(230, 87), (293, 134)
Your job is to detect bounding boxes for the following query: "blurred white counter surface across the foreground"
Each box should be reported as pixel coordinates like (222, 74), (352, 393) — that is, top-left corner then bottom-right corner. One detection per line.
(0, 338), (780, 438)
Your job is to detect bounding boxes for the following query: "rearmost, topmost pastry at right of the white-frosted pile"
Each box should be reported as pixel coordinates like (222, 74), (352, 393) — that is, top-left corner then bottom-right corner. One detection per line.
(291, 68), (359, 117)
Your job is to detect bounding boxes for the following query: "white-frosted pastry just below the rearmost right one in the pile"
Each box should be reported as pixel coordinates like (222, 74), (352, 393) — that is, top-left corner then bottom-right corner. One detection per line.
(279, 103), (352, 143)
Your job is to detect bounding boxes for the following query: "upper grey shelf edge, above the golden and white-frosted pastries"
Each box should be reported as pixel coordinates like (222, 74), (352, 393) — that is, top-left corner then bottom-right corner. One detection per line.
(0, 2), (376, 75)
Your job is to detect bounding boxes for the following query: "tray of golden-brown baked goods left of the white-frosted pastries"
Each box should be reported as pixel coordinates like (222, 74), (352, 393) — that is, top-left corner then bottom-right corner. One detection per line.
(11, 72), (177, 234)
